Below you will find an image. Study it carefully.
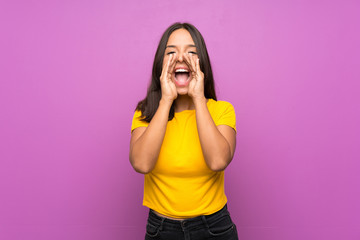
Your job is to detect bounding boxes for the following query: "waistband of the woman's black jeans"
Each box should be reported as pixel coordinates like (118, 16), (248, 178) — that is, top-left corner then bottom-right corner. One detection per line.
(148, 204), (230, 231)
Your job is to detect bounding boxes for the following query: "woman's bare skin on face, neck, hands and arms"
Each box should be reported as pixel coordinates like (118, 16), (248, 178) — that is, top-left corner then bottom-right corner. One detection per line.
(129, 29), (236, 220)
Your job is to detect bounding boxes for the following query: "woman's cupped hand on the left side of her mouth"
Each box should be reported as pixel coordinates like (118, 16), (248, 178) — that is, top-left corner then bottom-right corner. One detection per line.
(160, 54), (177, 103)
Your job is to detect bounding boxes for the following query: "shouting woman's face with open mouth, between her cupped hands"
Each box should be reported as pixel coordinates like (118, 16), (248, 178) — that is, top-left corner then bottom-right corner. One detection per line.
(163, 29), (197, 95)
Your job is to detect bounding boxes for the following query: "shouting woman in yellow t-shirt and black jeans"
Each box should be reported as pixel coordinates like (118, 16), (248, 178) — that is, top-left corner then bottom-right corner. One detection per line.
(129, 23), (238, 240)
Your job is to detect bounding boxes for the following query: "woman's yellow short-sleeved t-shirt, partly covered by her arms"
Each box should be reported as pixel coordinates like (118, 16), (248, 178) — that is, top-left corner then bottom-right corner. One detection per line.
(131, 99), (236, 218)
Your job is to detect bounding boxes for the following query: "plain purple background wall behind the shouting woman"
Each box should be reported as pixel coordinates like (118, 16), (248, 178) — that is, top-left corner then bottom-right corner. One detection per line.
(0, 0), (360, 240)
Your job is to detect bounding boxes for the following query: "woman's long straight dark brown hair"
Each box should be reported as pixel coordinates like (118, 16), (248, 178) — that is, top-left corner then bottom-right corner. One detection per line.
(136, 22), (217, 122)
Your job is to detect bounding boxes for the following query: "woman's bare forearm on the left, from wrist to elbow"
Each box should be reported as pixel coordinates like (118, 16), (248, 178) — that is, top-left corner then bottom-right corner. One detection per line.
(130, 100), (172, 173)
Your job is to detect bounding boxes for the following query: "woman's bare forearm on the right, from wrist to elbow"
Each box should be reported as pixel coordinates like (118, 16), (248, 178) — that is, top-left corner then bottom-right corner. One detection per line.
(194, 98), (232, 171)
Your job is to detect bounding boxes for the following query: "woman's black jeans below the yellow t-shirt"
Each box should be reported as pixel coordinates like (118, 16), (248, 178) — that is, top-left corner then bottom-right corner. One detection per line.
(145, 205), (238, 240)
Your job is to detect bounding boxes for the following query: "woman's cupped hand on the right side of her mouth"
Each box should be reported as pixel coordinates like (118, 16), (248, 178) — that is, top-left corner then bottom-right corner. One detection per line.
(184, 53), (205, 100)
